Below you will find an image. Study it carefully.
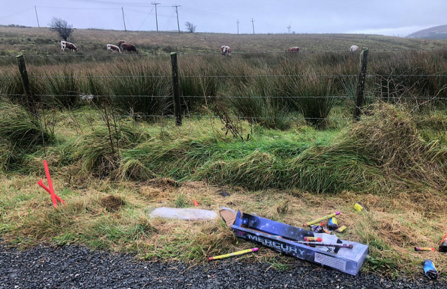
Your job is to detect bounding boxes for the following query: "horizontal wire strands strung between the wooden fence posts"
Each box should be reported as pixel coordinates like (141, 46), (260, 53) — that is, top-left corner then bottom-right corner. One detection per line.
(0, 49), (447, 127)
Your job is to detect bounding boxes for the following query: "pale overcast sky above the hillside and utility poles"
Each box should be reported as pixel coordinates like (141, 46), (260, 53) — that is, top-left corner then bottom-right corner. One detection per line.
(0, 0), (447, 36)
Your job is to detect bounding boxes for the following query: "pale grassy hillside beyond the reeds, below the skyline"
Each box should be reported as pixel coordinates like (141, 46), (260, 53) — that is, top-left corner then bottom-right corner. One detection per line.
(0, 27), (447, 55)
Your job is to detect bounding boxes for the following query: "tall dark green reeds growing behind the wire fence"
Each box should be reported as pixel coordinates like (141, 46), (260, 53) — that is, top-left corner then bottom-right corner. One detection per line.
(0, 51), (447, 129)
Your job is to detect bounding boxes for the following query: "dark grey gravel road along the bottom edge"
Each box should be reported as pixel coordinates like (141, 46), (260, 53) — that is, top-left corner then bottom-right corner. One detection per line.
(0, 244), (447, 289)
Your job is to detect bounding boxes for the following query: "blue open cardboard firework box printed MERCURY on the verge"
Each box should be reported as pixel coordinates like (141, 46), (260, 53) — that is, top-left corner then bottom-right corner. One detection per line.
(220, 208), (368, 276)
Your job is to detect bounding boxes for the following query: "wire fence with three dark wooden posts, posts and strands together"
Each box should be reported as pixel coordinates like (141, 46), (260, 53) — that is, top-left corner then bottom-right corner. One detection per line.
(0, 48), (447, 126)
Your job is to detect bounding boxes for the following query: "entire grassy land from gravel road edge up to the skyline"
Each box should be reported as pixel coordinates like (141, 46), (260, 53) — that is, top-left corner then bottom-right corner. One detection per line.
(0, 27), (447, 276)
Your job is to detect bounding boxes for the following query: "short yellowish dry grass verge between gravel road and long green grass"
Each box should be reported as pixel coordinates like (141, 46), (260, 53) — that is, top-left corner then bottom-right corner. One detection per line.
(0, 172), (447, 275)
